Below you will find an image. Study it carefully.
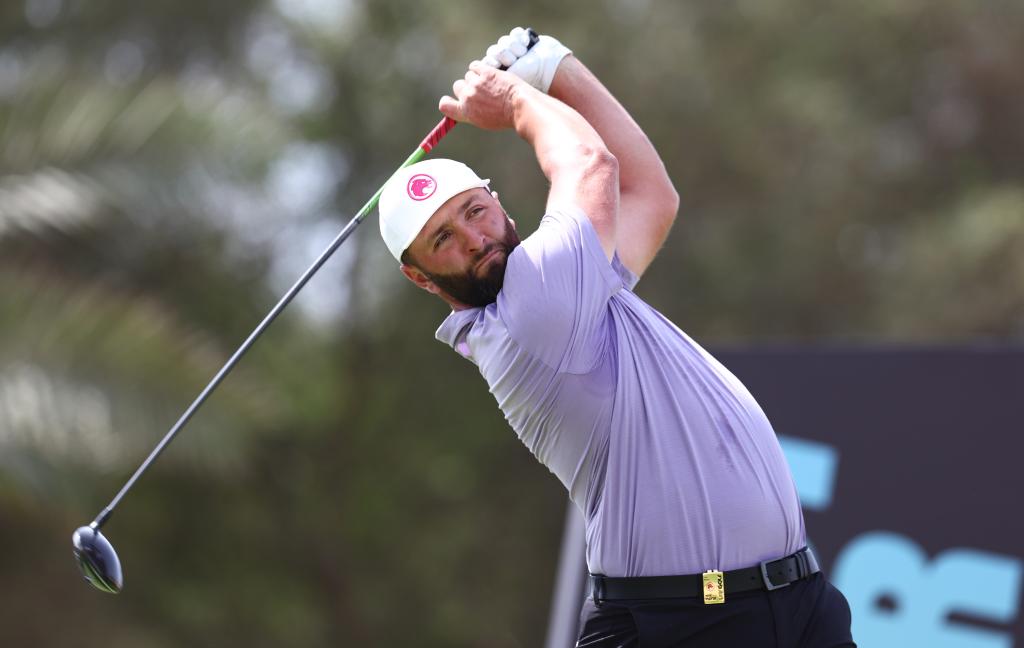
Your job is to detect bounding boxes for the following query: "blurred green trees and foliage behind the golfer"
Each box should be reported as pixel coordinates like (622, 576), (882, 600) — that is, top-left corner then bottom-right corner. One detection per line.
(0, 0), (1024, 648)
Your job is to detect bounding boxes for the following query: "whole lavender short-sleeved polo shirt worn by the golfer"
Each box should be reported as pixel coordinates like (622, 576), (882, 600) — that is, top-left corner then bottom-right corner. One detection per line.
(437, 207), (805, 576)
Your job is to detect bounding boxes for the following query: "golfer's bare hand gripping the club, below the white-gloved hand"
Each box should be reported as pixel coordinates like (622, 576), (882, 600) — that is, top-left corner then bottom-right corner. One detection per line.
(437, 60), (534, 130)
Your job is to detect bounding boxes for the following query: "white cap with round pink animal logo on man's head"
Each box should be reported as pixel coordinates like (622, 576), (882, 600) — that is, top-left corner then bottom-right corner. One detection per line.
(379, 159), (490, 262)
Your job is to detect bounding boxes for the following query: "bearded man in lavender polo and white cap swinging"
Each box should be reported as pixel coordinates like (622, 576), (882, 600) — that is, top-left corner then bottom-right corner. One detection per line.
(380, 30), (854, 648)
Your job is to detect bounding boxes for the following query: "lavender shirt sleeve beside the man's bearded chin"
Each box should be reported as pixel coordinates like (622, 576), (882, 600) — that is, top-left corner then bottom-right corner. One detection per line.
(498, 206), (622, 374)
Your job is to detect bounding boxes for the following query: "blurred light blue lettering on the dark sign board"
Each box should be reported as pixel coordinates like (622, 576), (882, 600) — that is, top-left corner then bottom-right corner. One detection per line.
(780, 437), (1022, 648)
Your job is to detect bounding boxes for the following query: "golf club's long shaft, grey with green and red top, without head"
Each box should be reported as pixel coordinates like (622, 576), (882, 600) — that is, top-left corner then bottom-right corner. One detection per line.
(90, 117), (448, 528)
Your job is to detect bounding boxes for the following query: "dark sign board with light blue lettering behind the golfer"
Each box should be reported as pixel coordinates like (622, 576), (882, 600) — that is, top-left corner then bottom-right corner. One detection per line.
(716, 348), (1024, 648)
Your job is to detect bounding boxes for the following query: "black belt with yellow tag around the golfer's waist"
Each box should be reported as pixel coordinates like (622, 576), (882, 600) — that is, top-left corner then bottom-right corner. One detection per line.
(590, 548), (821, 604)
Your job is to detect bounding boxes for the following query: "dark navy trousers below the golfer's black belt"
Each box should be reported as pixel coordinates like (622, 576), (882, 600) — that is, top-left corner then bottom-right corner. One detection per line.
(577, 572), (856, 648)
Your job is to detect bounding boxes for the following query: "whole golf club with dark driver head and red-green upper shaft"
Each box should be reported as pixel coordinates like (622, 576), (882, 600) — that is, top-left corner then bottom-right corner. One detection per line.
(72, 29), (540, 594)
